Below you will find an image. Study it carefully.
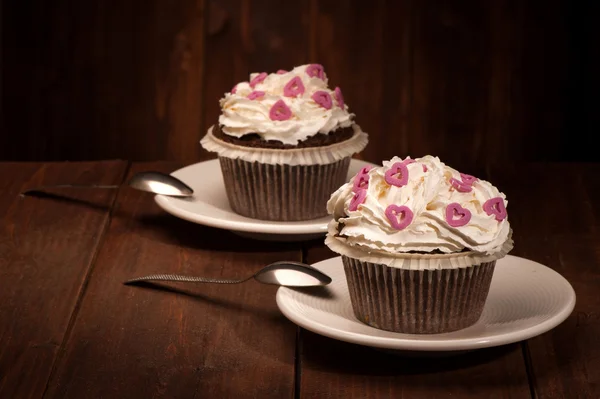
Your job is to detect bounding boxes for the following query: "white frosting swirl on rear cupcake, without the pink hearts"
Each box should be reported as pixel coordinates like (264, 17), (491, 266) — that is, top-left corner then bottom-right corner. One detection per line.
(219, 65), (354, 145)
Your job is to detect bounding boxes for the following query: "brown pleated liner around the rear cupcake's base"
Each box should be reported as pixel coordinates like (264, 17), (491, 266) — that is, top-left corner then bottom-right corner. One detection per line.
(219, 157), (350, 221)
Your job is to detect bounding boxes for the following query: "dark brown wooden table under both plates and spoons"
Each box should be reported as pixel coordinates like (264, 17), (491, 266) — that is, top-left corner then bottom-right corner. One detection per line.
(0, 161), (600, 399)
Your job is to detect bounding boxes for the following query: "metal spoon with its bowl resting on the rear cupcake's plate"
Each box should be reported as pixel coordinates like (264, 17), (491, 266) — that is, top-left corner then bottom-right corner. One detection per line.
(21, 172), (194, 197)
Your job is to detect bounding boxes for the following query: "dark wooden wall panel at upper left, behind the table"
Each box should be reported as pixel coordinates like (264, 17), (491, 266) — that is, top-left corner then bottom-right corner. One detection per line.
(0, 0), (205, 161)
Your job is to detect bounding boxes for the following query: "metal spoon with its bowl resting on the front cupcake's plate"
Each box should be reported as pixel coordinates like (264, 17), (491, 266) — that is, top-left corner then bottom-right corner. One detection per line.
(124, 261), (331, 287)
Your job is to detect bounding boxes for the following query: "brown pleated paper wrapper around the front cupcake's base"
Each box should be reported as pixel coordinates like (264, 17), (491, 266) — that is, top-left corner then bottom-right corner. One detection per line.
(342, 256), (496, 334)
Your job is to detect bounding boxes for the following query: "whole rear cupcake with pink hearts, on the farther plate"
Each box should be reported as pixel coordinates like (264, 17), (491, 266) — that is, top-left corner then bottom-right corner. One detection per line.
(200, 64), (368, 221)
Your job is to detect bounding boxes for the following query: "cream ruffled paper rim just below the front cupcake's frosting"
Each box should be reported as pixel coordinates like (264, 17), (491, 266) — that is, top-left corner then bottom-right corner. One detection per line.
(325, 220), (514, 270)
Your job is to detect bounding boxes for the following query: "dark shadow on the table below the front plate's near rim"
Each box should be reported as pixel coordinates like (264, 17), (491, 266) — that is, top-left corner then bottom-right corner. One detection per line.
(301, 330), (521, 376)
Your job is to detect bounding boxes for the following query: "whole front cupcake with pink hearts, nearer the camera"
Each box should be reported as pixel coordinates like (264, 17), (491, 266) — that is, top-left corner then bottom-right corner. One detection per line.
(325, 156), (513, 334)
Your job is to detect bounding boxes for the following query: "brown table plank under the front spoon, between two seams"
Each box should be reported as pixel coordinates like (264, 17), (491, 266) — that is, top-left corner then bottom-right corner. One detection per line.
(47, 163), (301, 398)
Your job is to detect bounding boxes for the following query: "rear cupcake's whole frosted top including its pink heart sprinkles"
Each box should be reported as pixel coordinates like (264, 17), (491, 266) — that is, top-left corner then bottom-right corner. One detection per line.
(219, 64), (354, 145)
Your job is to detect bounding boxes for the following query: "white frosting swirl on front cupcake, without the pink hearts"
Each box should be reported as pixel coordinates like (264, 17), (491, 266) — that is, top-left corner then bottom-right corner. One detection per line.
(327, 155), (510, 254)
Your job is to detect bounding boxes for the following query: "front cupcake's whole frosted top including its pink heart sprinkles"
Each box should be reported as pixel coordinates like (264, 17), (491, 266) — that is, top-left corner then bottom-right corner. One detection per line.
(327, 155), (511, 255)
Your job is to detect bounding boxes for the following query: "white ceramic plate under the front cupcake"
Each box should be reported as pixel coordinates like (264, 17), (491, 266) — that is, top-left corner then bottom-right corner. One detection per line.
(277, 255), (575, 351)
